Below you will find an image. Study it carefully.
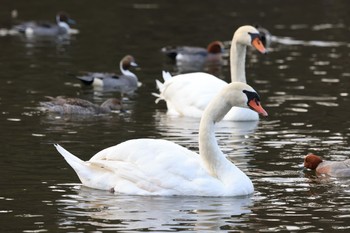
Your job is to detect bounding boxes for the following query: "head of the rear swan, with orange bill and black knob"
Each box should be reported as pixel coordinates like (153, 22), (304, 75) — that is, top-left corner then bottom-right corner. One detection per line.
(233, 25), (266, 53)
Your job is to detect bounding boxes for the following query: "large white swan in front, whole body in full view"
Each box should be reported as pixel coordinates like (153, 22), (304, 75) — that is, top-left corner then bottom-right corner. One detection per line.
(55, 82), (267, 196)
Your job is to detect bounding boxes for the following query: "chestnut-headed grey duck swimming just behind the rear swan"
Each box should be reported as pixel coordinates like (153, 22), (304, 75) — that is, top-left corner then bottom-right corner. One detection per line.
(161, 41), (224, 72)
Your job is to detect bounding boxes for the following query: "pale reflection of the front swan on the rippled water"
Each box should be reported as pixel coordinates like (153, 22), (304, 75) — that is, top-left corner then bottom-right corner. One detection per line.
(54, 184), (252, 231)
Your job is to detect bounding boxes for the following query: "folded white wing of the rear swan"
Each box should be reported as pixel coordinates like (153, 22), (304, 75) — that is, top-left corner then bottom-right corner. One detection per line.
(160, 72), (227, 117)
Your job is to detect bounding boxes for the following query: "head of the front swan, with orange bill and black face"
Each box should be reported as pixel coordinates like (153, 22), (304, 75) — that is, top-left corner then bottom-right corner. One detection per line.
(228, 82), (268, 116)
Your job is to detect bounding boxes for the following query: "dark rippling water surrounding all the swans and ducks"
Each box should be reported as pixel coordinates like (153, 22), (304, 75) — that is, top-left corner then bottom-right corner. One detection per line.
(0, 0), (350, 232)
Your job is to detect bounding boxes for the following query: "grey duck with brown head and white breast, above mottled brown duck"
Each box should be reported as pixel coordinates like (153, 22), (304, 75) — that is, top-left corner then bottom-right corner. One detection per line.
(77, 55), (142, 94)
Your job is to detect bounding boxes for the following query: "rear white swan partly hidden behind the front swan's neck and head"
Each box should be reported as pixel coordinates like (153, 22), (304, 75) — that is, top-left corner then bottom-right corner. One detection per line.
(154, 26), (266, 121)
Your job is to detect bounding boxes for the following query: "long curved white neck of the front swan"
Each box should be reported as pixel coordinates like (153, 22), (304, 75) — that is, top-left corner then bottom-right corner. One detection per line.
(199, 93), (232, 179)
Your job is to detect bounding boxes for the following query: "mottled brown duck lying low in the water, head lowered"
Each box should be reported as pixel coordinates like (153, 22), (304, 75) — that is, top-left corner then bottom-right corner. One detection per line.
(40, 96), (122, 115)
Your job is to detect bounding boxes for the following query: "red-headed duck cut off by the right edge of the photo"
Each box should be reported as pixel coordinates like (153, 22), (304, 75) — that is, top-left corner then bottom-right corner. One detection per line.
(304, 153), (350, 177)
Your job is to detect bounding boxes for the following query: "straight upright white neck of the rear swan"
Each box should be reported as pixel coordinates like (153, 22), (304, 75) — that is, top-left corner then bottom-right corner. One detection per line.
(230, 39), (247, 83)
